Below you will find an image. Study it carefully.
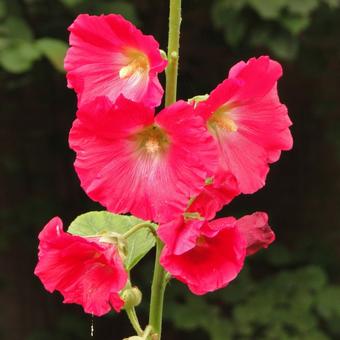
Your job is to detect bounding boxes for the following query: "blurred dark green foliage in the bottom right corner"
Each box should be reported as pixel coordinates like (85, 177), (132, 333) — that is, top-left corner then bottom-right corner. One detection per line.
(166, 246), (340, 340)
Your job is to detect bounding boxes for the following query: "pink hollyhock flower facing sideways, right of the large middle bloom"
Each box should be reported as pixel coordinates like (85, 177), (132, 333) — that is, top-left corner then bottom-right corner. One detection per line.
(196, 56), (292, 194)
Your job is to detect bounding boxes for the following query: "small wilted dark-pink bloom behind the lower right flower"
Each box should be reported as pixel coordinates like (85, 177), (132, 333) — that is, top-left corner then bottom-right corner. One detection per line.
(237, 212), (275, 255)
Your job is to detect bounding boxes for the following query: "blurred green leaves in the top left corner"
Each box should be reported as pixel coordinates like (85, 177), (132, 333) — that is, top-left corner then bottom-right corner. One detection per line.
(0, 0), (138, 73)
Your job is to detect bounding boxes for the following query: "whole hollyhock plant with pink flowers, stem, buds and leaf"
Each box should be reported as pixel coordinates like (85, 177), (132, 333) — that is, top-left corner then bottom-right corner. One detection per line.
(35, 0), (292, 340)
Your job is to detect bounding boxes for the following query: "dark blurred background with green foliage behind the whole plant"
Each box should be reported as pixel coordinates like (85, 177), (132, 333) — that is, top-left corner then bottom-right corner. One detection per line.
(0, 0), (340, 340)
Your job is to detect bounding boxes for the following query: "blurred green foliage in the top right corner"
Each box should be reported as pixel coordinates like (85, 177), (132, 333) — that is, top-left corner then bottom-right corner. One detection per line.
(212, 0), (340, 60)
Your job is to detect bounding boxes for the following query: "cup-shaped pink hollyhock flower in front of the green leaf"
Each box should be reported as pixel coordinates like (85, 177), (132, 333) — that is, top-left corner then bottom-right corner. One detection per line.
(34, 217), (128, 316)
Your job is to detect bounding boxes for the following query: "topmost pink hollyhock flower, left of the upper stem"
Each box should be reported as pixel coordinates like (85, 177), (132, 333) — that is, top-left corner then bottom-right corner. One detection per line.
(65, 14), (167, 107)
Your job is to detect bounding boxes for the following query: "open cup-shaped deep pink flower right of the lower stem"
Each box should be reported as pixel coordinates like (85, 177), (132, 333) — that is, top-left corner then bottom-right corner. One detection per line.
(157, 217), (246, 295)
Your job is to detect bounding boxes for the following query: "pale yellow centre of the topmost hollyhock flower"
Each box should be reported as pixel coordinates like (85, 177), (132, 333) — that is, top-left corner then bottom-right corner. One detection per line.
(119, 49), (149, 79)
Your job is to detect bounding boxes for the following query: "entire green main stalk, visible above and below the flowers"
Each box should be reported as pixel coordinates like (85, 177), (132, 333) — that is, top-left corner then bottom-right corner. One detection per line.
(149, 0), (182, 340)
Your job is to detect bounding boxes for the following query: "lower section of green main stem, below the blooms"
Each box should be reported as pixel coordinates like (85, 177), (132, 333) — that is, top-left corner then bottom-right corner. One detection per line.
(149, 239), (167, 340)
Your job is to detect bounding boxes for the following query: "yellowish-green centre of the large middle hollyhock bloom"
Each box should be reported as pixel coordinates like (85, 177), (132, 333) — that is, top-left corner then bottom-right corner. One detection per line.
(137, 125), (169, 155)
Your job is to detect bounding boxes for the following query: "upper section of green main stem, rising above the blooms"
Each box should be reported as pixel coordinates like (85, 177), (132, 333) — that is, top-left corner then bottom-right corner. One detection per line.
(165, 0), (182, 106)
